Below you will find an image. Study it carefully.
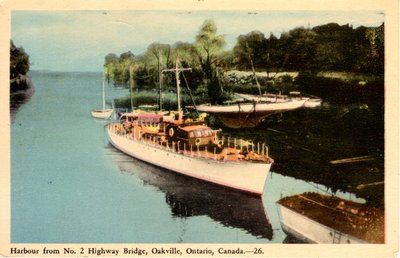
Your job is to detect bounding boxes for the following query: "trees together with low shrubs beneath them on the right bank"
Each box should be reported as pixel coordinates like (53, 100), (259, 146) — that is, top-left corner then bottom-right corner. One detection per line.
(105, 20), (384, 107)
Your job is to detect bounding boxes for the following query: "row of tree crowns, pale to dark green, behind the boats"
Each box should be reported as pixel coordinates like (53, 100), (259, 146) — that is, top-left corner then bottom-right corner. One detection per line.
(105, 20), (384, 103)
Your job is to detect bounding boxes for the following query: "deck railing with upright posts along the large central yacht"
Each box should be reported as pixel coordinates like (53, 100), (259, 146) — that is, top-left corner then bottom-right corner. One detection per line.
(108, 123), (270, 162)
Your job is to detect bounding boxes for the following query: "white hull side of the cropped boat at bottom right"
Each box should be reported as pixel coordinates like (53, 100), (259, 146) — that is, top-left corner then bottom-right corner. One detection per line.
(277, 203), (368, 244)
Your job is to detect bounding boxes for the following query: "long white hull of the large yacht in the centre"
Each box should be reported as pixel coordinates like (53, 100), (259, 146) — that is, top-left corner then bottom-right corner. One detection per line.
(106, 124), (271, 195)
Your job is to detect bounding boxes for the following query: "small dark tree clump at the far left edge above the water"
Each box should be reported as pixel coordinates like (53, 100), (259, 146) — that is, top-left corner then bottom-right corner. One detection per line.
(10, 41), (29, 79)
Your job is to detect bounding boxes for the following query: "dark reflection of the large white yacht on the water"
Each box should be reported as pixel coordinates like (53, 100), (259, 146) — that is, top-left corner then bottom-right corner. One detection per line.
(108, 146), (273, 240)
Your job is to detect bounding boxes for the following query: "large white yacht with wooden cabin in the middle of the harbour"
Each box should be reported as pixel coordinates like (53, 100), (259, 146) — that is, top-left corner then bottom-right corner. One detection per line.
(106, 113), (273, 195)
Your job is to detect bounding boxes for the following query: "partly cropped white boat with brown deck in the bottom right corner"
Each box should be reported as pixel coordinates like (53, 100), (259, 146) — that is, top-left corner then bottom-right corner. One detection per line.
(277, 193), (384, 244)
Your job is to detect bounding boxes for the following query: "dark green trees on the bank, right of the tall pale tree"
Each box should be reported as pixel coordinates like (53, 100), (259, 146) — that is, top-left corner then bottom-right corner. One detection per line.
(232, 23), (384, 75)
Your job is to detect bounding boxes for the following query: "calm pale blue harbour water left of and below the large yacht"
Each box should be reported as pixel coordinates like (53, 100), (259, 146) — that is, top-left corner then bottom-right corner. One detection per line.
(11, 72), (362, 243)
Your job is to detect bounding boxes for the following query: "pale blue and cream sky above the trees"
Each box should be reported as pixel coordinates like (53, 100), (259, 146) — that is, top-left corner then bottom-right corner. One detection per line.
(11, 10), (385, 72)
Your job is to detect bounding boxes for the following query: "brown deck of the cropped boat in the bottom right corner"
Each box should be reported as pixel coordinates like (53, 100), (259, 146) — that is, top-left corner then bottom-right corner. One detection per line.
(278, 193), (384, 243)
